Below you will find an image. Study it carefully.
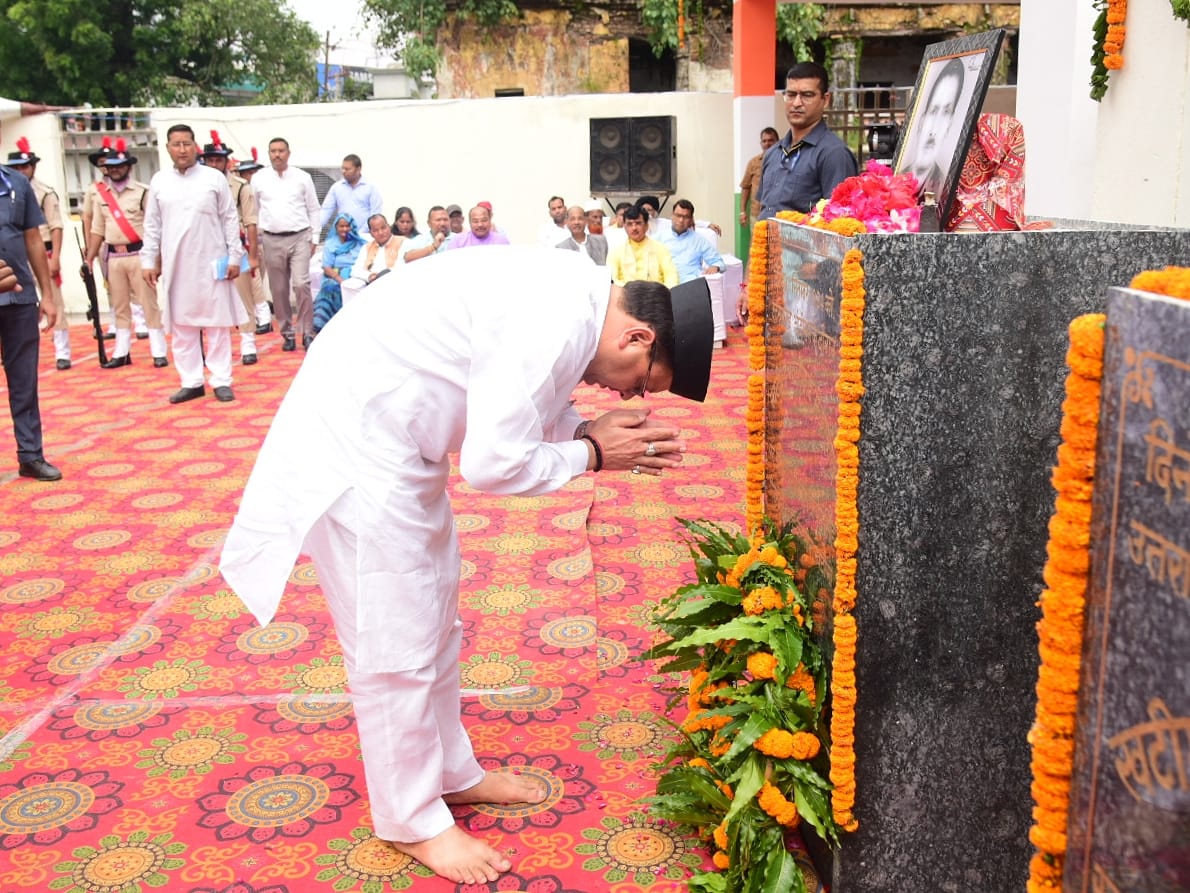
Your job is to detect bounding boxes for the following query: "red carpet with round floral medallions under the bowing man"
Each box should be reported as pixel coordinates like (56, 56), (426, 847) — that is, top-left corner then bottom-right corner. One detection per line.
(0, 326), (747, 893)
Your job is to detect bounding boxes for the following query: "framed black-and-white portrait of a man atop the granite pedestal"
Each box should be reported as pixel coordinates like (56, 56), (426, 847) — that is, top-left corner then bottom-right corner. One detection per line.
(893, 29), (1004, 220)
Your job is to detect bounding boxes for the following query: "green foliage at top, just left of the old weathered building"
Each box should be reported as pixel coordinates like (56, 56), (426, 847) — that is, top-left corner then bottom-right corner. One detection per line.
(363, 0), (520, 77)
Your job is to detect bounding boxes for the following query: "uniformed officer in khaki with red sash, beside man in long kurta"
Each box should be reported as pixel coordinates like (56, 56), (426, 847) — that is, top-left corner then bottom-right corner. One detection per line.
(86, 139), (169, 369)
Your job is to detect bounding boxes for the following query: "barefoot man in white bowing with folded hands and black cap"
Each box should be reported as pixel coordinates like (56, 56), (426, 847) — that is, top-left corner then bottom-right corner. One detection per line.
(220, 246), (713, 883)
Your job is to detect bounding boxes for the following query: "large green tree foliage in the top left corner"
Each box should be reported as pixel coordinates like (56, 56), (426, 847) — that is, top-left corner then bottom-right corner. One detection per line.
(0, 0), (318, 106)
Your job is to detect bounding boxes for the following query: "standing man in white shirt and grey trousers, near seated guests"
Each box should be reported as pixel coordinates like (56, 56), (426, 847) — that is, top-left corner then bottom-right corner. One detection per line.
(252, 137), (319, 350)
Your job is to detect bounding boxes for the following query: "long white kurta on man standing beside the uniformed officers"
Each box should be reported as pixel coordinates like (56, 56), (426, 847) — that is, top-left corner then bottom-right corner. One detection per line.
(140, 164), (248, 327)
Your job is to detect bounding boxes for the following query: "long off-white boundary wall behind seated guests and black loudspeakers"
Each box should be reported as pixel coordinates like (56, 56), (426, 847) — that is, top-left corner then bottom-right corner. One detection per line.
(0, 93), (738, 312)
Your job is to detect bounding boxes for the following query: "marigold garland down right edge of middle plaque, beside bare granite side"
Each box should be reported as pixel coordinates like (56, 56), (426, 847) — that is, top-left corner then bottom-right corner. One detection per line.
(831, 242), (865, 831)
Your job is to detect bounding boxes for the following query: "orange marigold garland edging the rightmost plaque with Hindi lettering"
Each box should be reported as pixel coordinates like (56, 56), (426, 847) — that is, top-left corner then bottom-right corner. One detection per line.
(1028, 313), (1104, 893)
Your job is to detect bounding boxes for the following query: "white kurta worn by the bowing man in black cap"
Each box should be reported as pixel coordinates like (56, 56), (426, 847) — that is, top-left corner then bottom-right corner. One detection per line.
(220, 246), (609, 673)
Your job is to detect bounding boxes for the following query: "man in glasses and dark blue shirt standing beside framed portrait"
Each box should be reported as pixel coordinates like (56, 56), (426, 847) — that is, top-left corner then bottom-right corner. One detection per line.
(756, 62), (859, 220)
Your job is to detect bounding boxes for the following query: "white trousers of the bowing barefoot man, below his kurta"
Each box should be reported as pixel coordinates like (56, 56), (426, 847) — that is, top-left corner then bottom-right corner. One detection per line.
(303, 495), (483, 843)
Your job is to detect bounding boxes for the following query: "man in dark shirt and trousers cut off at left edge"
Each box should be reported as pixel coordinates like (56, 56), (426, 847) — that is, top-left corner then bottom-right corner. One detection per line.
(0, 166), (62, 481)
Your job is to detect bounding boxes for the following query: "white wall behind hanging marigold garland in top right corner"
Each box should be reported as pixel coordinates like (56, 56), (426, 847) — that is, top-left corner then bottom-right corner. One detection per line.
(1016, 0), (1190, 227)
